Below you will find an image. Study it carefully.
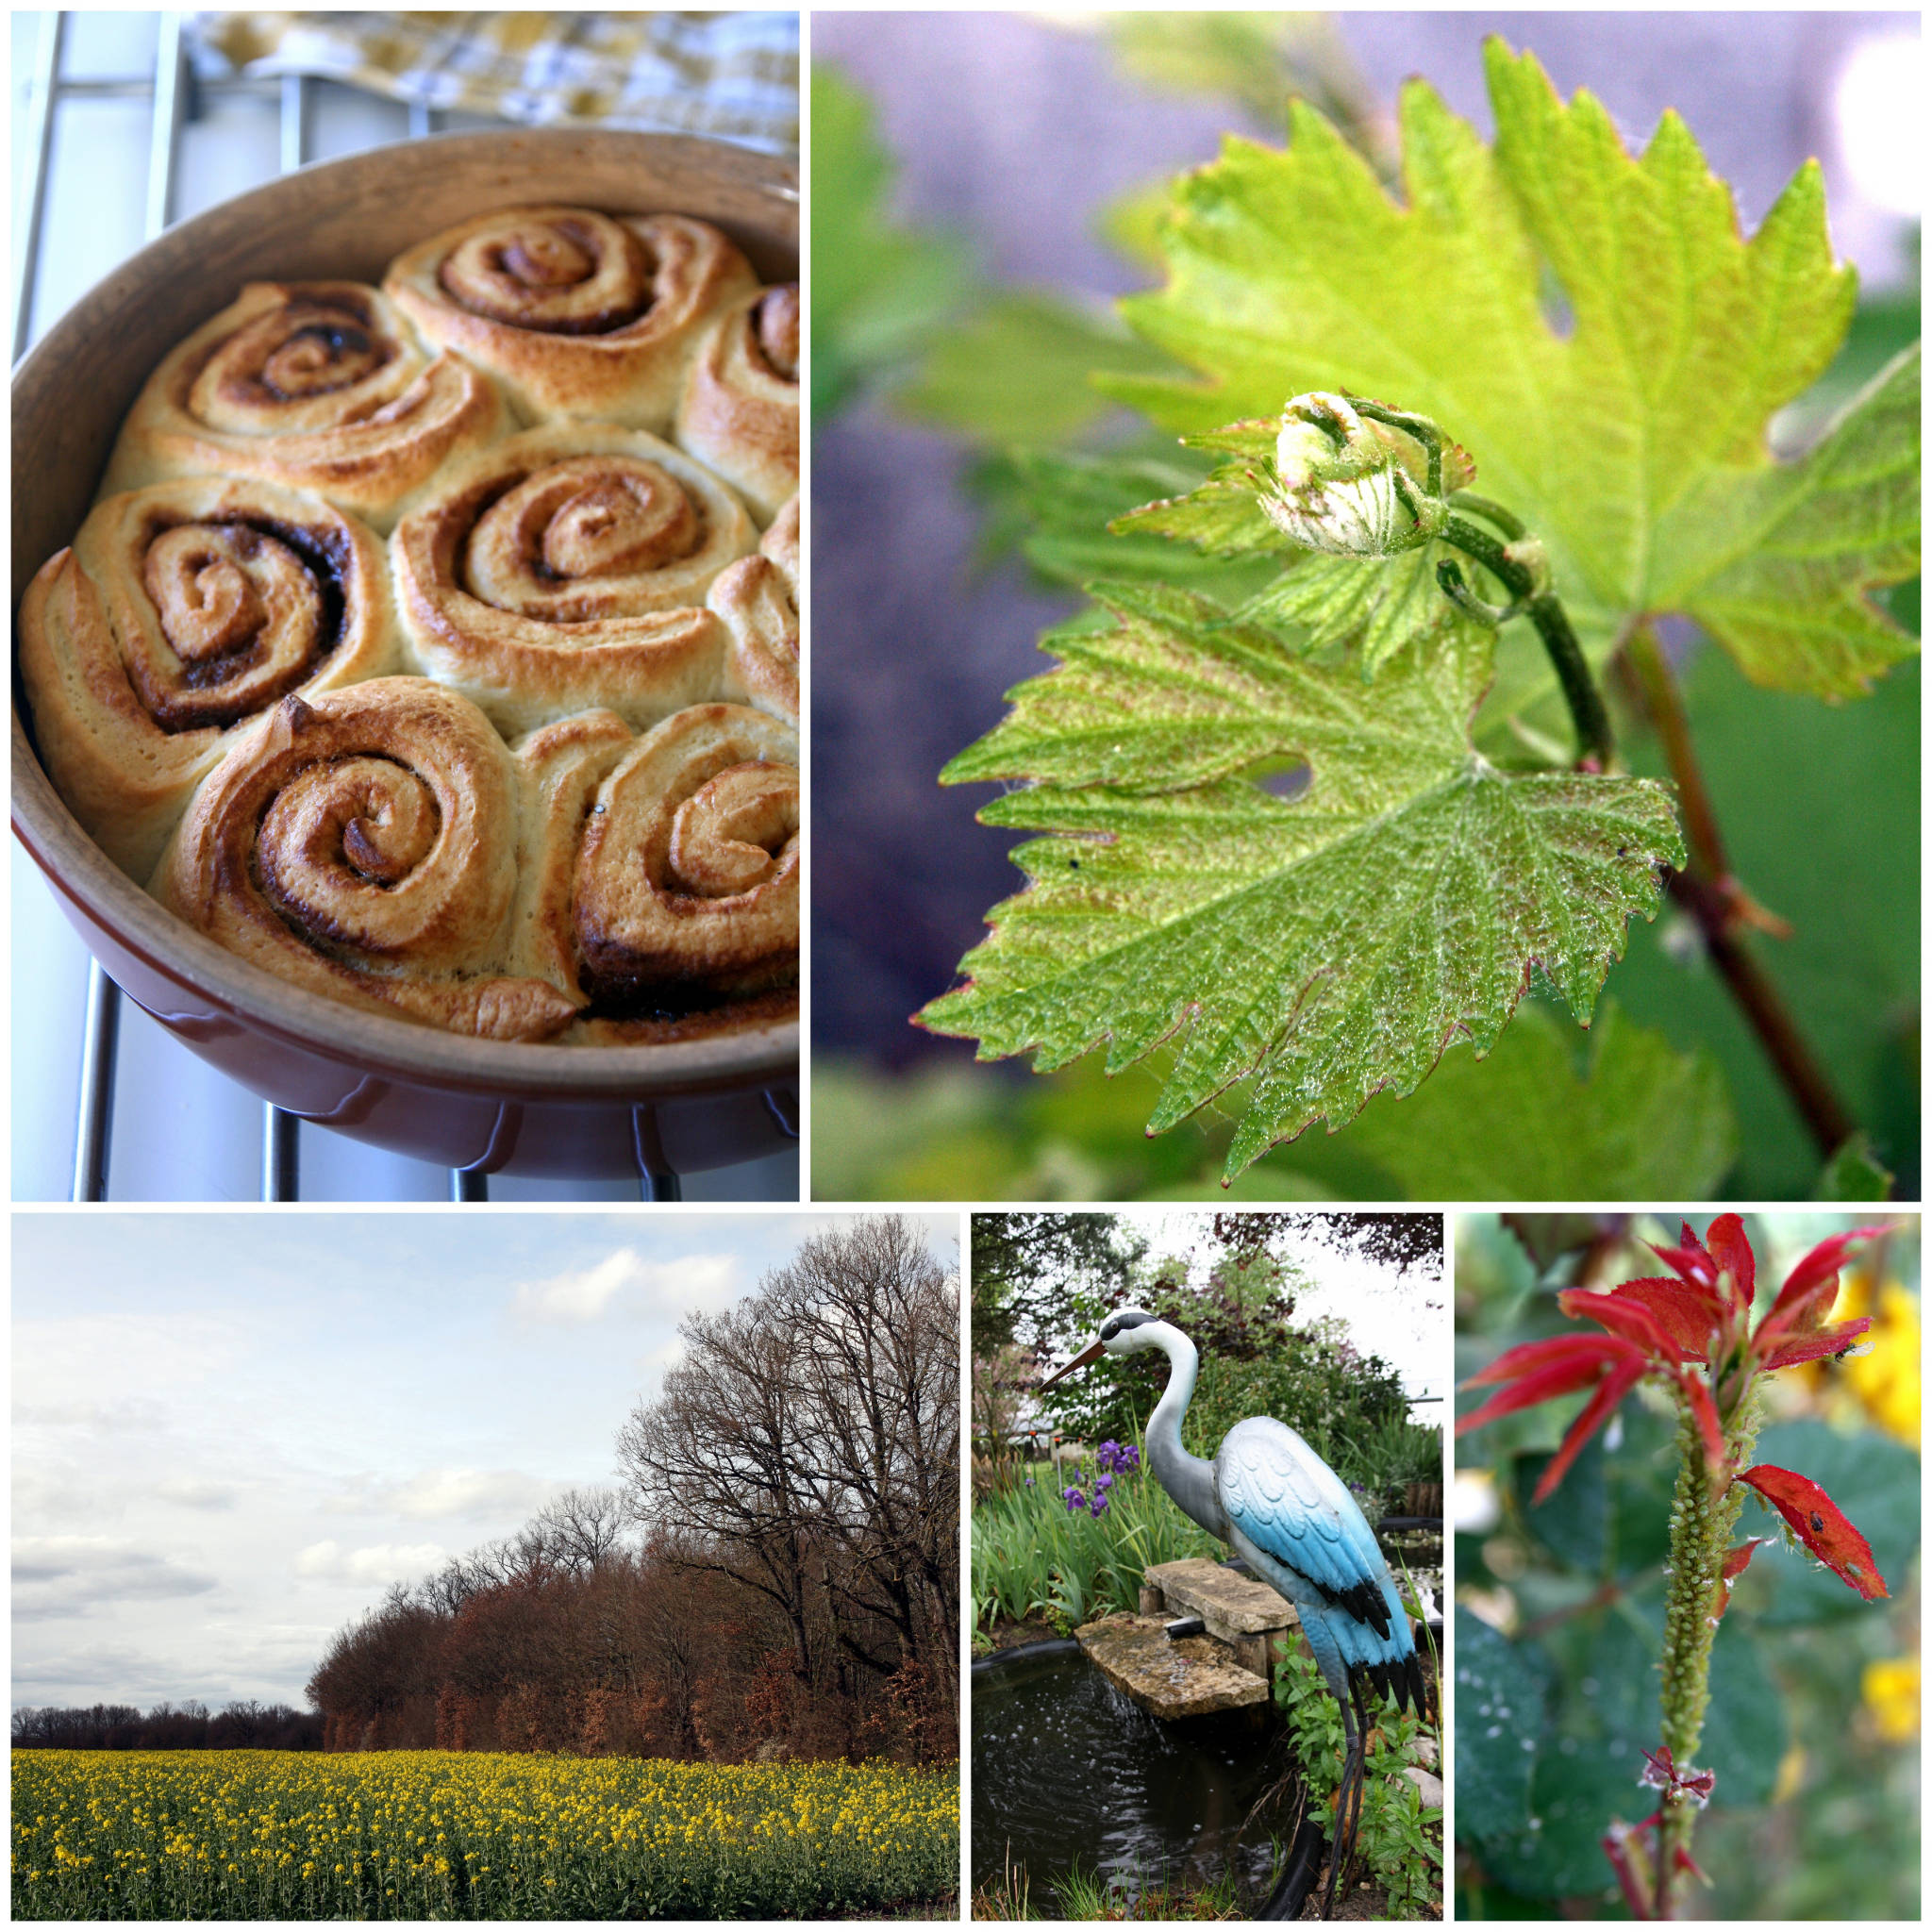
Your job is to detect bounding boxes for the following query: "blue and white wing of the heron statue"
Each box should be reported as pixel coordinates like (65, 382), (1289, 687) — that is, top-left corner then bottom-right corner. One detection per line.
(1215, 1416), (1407, 1639)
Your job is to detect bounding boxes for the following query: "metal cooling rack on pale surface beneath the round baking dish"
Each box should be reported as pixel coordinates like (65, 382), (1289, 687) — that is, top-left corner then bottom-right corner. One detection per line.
(9, 11), (798, 1202)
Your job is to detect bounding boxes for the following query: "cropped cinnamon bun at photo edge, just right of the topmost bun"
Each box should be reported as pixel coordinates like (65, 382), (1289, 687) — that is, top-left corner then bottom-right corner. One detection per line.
(675, 282), (798, 524)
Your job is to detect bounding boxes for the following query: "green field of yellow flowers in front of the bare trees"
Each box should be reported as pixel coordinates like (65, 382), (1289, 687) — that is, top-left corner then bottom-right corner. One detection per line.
(13, 1750), (960, 1919)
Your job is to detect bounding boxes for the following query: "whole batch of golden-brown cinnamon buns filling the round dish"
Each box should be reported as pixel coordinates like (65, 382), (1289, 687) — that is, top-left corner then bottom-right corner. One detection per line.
(30, 207), (800, 1045)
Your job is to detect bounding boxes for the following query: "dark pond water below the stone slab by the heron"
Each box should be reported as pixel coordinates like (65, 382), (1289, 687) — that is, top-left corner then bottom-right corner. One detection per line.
(972, 1650), (1289, 1917)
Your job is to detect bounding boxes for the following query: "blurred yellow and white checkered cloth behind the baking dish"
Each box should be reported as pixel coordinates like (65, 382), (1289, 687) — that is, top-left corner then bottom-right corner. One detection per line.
(195, 13), (798, 155)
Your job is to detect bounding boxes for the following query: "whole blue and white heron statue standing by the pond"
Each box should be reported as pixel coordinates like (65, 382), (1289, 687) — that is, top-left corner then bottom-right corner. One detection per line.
(1040, 1307), (1425, 1919)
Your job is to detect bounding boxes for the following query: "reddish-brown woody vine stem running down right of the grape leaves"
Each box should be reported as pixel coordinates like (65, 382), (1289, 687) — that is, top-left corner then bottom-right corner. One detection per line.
(1623, 625), (1857, 1159)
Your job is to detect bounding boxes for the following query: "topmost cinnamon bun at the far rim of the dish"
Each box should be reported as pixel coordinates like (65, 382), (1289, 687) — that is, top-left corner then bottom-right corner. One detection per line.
(383, 207), (758, 431)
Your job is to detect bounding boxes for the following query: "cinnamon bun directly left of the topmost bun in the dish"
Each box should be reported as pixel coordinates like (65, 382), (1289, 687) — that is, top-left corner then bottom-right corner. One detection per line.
(103, 282), (516, 533)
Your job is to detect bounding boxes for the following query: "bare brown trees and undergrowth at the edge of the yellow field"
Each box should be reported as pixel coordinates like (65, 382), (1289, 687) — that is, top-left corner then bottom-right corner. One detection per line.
(309, 1217), (960, 1760)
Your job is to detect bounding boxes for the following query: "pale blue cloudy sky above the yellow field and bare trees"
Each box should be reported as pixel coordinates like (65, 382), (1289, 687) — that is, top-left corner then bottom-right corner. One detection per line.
(11, 1208), (958, 1707)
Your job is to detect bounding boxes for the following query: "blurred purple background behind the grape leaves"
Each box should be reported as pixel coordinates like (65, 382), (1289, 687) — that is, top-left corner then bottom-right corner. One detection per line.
(811, 13), (1919, 1064)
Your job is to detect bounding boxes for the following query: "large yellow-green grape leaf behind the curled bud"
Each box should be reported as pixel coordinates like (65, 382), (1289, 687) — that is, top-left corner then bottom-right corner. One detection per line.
(1103, 39), (1919, 697)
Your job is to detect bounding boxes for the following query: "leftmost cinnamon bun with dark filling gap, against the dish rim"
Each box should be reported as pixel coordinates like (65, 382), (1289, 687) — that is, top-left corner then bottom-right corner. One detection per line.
(19, 477), (398, 879)
